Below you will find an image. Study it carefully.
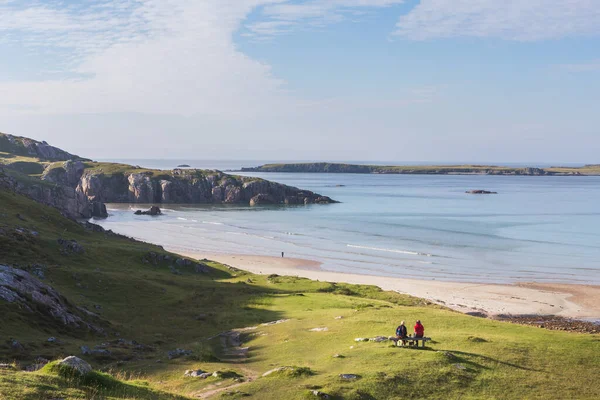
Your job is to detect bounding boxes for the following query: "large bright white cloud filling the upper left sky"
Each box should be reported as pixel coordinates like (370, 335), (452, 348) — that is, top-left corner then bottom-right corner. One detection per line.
(0, 0), (292, 116)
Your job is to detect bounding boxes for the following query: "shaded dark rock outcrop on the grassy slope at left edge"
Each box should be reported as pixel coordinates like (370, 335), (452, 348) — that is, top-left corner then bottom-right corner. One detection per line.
(0, 265), (102, 332)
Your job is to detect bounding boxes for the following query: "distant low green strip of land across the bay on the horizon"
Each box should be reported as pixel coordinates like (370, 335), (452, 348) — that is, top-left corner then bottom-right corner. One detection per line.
(240, 162), (600, 176)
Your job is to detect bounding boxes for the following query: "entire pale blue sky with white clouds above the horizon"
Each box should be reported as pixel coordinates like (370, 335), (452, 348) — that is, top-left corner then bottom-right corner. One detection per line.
(0, 0), (600, 163)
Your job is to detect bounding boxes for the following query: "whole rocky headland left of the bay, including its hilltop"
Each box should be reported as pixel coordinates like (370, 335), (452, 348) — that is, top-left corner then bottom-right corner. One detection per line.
(0, 134), (337, 222)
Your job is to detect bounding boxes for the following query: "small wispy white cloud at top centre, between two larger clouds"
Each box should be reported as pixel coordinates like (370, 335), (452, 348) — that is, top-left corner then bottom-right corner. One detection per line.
(246, 0), (405, 38)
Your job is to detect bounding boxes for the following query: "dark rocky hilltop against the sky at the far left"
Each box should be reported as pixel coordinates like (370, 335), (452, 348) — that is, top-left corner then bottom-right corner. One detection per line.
(0, 133), (82, 161)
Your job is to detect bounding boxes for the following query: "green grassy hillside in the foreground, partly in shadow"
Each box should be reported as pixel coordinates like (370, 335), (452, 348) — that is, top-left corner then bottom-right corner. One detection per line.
(0, 190), (600, 400)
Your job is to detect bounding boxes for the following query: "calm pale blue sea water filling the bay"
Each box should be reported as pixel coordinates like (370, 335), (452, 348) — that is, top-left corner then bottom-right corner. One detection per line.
(94, 161), (600, 284)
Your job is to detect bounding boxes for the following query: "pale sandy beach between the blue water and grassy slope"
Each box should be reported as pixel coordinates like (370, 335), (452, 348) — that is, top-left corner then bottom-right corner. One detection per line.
(167, 248), (600, 318)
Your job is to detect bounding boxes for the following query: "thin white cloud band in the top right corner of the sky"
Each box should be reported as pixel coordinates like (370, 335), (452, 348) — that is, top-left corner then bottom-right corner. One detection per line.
(395, 0), (600, 41)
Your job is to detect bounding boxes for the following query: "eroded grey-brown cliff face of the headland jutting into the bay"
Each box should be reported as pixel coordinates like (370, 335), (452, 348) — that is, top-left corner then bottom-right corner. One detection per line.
(42, 161), (335, 205)
